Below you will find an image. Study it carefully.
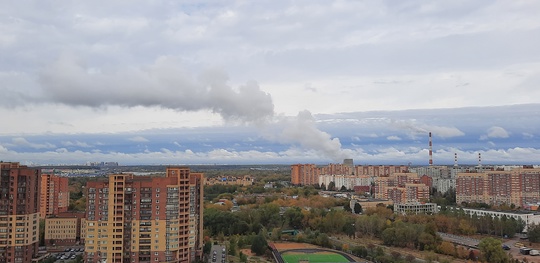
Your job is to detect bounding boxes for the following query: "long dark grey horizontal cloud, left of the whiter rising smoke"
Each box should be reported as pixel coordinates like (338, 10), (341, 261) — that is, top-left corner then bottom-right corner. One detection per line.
(37, 54), (274, 125)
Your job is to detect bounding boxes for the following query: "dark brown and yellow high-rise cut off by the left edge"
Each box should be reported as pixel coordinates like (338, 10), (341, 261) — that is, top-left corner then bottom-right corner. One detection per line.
(0, 162), (41, 263)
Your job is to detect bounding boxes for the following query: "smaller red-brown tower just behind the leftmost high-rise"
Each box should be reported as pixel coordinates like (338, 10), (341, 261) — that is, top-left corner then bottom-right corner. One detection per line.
(40, 173), (69, 218)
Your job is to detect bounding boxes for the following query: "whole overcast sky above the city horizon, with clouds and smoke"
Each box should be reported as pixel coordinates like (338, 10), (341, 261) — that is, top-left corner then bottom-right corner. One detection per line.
(0, 0), (540, 165)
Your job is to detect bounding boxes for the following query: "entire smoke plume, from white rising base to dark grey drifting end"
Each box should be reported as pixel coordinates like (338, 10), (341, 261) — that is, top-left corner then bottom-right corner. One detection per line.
(40, 56), (346, 161)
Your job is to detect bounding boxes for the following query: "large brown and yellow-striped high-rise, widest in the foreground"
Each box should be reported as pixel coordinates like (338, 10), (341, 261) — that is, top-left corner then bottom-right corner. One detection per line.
(85, 167), (204, 263)
